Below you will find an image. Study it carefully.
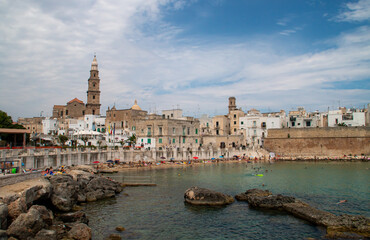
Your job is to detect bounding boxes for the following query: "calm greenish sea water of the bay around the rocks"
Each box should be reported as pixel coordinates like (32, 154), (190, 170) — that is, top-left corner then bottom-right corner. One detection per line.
(84, 162), (370, 239)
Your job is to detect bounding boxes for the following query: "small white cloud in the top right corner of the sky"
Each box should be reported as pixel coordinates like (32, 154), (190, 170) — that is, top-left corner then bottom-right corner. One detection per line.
(336, 0), (370, 22)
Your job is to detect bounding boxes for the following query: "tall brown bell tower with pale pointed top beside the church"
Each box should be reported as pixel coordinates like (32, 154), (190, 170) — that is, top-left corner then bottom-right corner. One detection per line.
(86, 55), (101, 115)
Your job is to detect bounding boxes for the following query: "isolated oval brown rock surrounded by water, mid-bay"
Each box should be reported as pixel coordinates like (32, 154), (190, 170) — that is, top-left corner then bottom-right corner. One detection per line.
(184, 187), (234, 206)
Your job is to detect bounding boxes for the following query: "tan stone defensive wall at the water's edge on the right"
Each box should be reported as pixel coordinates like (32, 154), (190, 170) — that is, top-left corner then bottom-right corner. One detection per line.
(264, 127), (370, 158)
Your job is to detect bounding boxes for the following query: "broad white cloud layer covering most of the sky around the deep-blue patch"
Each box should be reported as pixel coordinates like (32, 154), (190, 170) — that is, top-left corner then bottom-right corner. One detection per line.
(0, 0), (370, 120)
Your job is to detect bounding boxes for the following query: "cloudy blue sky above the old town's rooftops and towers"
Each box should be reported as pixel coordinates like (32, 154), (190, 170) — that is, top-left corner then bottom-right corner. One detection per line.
(0, 0), (370, 120)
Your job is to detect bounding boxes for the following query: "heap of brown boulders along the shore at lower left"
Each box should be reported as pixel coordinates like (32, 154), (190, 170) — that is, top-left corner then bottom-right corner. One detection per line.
(0, 166), (122, 240)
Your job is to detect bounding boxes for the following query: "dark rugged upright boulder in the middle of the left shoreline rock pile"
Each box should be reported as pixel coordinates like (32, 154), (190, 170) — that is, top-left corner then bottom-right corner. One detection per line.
(49, 175), (80, 212)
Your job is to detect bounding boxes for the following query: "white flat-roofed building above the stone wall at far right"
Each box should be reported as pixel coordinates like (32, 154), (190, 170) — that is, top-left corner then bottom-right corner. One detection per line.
(328, 108), (366, 127)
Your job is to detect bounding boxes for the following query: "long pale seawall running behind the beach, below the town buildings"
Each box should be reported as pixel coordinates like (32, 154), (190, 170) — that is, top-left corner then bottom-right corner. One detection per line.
(0, 148), (268, 169)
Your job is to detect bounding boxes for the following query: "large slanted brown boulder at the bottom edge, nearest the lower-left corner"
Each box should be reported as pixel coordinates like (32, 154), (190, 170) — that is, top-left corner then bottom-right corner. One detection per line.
(7, 205), (53, 239)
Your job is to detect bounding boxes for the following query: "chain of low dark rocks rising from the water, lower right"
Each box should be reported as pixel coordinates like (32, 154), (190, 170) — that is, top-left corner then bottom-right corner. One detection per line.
(184, 187), (370, 239)
